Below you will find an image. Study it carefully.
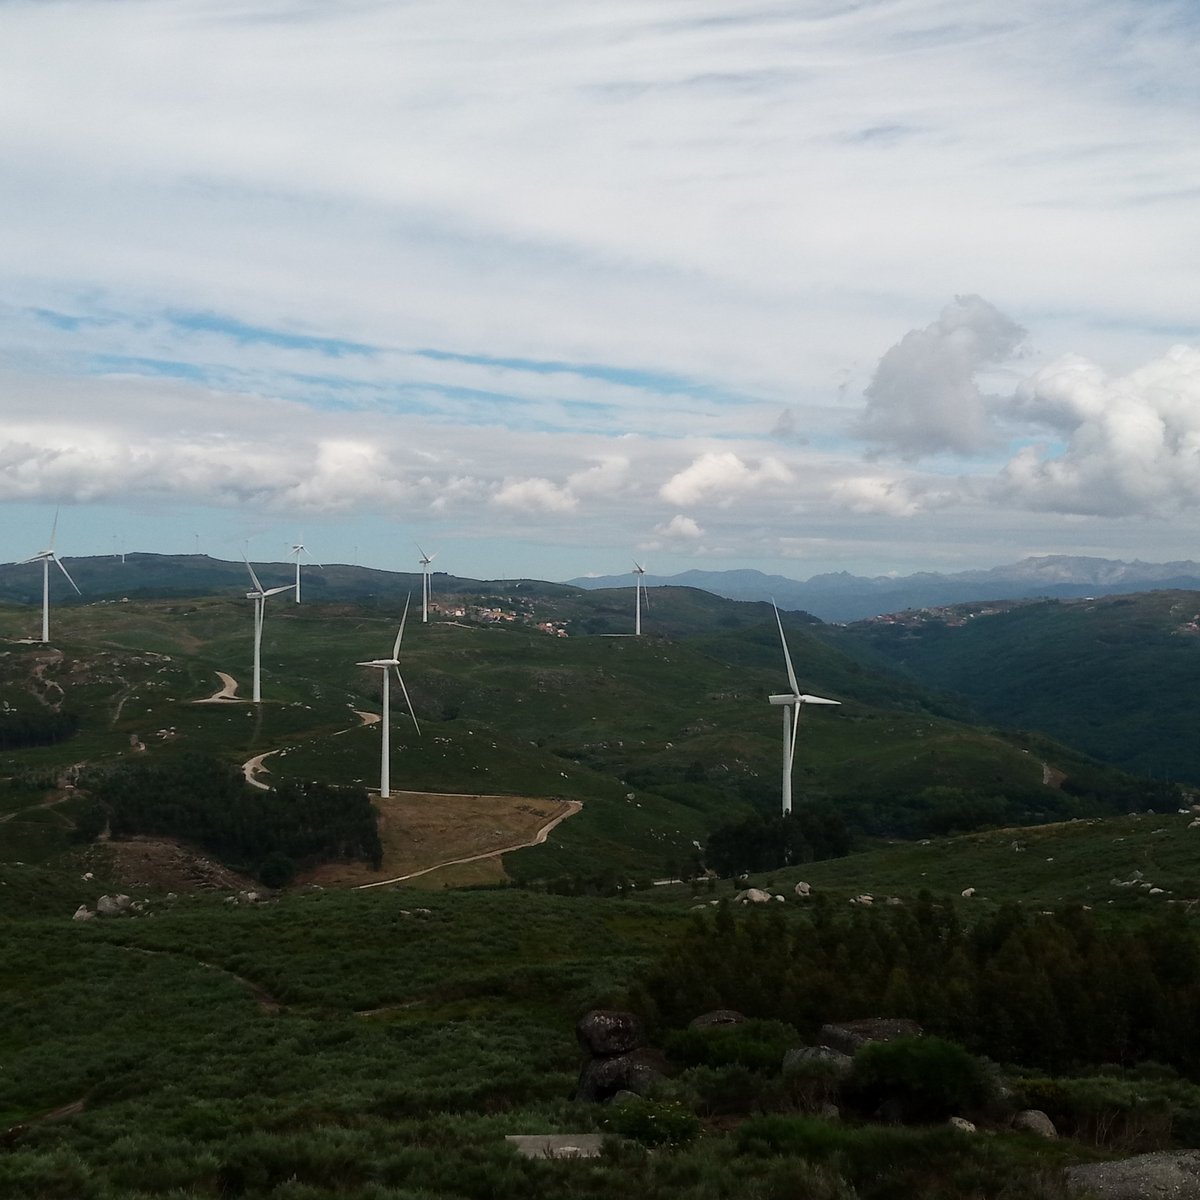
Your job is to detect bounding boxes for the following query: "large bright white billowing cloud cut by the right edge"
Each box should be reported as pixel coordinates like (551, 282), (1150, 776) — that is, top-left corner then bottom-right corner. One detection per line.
(991, 346), (1200, 516)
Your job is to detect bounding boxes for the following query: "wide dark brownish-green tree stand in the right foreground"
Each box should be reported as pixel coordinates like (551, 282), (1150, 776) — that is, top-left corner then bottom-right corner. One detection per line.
(634, 894), (1200, 1078)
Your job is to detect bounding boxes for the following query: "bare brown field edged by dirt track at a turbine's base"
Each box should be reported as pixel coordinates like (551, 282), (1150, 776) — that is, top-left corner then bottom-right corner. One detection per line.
(299, 792), (578, 887)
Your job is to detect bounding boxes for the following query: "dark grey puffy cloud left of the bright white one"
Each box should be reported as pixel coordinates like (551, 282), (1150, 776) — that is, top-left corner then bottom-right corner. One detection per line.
(852, 295), (1025, 458)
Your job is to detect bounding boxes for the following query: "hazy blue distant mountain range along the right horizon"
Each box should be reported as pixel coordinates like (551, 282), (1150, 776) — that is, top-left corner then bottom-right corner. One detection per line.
(569, 554), (1200, 622)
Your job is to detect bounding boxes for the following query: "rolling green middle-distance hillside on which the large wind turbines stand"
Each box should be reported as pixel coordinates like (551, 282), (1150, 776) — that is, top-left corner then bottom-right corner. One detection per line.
(0, 586), (1152, 877)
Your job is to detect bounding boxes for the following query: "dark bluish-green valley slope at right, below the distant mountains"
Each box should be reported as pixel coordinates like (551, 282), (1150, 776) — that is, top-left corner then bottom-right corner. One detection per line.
(823, 592), (1200, 784)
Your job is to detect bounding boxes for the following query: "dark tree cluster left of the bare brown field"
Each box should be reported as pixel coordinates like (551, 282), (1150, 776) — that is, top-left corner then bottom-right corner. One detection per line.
(85, 754), (383, 881)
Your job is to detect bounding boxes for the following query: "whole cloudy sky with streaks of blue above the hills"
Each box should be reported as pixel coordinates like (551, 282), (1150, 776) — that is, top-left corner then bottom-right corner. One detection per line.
(0, 0), (1200, 580)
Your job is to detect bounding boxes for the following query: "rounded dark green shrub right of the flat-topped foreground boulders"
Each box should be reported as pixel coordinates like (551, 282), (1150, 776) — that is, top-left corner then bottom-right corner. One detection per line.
(846, 1037), (990, 1121)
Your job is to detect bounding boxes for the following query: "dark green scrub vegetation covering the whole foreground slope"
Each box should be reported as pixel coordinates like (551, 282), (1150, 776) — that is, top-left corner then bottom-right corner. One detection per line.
(7, 865), (1200, 1200)
